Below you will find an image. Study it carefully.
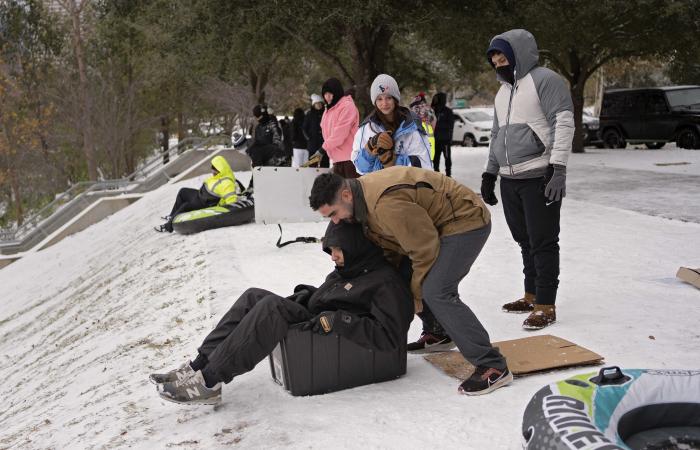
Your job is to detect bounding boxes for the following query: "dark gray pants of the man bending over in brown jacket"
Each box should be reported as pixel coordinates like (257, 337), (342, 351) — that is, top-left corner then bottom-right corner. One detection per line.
(423, 223), (506, 370)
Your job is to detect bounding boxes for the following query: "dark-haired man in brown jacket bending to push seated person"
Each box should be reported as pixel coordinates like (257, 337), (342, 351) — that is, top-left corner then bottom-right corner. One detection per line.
(309, 166), (513, 395)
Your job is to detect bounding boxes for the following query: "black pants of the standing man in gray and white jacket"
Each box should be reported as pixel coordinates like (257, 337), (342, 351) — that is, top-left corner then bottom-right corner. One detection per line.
(501, 178), (561, 305)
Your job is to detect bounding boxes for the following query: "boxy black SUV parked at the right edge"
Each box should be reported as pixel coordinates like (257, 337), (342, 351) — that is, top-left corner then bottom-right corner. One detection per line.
(600, 86), (700, 149)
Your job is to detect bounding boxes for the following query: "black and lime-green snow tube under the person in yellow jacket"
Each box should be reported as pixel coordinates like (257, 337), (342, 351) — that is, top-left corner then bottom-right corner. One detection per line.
(173, 194), (255, 234)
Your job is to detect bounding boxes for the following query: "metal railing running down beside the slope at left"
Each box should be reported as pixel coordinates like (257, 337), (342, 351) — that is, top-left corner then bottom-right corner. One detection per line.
(0, 134), (230, 245)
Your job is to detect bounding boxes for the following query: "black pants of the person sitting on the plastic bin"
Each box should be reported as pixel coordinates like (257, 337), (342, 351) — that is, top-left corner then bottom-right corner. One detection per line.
(194, 288), (313, 383)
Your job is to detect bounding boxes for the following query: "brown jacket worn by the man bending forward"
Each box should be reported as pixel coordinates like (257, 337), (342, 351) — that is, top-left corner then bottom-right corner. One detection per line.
(351, 166), (491, 312)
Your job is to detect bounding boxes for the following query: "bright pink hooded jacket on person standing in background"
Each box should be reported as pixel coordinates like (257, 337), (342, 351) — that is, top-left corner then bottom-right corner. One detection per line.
(321, 95), (360, 163)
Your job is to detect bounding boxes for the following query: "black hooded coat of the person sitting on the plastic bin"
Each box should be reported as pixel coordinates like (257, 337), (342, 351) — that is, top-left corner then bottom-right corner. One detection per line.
(290, 222), (413, 351)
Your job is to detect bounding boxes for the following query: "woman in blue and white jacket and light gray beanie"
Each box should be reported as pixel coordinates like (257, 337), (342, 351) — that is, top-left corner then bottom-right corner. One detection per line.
(350, 74), (433, 175)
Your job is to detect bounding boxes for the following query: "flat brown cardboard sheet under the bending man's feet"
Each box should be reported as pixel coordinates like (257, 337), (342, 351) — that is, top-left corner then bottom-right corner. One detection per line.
(425, 334), (603, 380)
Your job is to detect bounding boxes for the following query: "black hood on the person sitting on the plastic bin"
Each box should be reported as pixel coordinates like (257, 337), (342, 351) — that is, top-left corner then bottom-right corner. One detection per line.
(323, 221), (386, 279)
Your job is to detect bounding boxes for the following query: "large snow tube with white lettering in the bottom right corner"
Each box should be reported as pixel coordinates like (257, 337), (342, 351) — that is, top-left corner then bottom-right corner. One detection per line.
(522, 367), (700, 450)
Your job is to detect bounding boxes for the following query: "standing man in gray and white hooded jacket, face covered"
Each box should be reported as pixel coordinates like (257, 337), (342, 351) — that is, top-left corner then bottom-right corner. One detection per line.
(481, 29), (574, 329)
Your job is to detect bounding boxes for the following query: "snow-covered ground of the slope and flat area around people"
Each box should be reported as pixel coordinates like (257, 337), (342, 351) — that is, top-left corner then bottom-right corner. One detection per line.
(0, 147), (700, 449)
